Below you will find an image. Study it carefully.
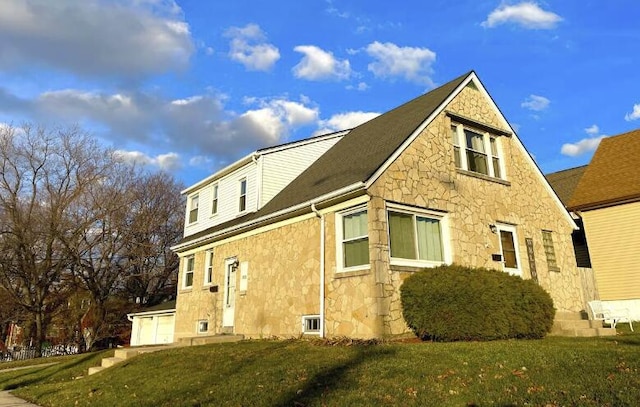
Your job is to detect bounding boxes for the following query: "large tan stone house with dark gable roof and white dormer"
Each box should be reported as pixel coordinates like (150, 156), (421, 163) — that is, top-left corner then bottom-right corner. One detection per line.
(174, 72), (584, 340)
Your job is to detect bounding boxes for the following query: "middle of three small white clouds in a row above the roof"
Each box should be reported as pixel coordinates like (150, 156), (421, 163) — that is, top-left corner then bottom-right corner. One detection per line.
(292, 45), (351, 81)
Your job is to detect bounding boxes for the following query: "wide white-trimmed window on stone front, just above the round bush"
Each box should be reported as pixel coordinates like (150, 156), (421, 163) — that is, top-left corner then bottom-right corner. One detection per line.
(387, 206), (446, 265)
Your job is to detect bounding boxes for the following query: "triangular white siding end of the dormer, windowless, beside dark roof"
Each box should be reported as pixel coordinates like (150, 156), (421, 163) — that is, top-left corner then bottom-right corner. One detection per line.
(260, 137), (342, 207)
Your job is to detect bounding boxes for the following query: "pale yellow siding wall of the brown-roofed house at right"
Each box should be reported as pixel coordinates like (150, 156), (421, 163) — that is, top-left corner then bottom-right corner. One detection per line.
(582, 202), (640, 300)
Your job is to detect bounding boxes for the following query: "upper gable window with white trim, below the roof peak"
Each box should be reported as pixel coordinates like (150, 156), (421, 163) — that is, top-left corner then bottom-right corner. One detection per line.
(451, 123), (503, 178)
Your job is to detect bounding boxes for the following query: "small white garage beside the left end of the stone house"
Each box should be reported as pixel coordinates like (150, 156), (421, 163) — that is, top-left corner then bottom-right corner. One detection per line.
(127, 301), (176, 346)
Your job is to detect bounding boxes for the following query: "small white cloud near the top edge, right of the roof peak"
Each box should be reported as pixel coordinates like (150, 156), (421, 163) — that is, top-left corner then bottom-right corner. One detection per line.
(481, 1), (562, 29)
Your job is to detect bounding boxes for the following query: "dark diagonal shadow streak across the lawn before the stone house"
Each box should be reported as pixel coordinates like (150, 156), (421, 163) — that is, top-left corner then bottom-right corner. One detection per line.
(274, 345), (396, 407)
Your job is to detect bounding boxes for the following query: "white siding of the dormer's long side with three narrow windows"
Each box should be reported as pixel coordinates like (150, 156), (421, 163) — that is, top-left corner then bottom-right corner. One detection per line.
(184, 162), (258, 237)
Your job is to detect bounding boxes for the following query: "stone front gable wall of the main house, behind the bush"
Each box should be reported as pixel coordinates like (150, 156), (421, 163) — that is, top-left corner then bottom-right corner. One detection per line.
(369, 84), (583, 334)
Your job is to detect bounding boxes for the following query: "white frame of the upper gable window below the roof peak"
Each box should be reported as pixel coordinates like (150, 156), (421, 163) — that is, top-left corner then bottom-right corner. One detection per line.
(451, 122), (506, 180)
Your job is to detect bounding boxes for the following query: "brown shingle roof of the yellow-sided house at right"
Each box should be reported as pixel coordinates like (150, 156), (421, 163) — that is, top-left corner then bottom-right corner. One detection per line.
(568, 129), (640, 210)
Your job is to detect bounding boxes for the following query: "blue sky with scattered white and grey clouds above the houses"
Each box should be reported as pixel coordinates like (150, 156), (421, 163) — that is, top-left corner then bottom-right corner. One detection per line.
(0, 0), (640, 184)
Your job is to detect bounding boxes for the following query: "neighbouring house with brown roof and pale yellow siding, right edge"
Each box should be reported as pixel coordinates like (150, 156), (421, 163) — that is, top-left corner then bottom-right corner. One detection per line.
(567, 129), (640, 320)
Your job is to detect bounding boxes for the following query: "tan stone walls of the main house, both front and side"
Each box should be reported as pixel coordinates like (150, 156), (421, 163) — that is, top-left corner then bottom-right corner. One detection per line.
(175, 83), (584, 339)
